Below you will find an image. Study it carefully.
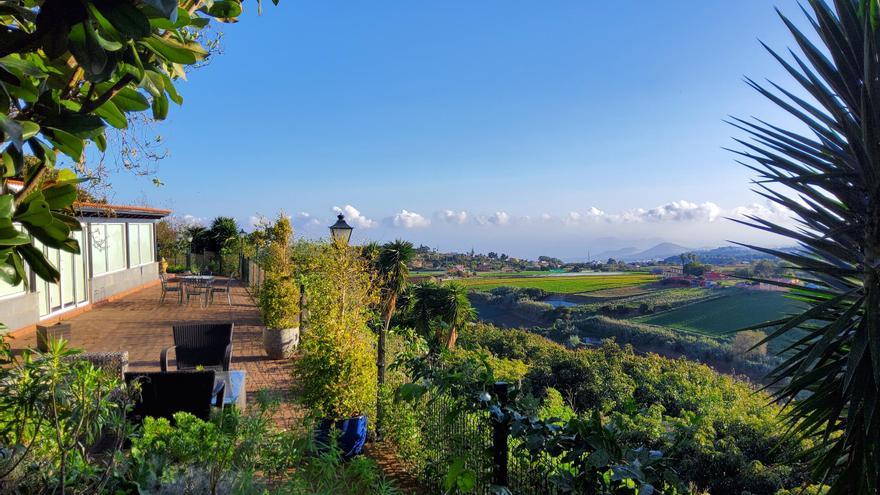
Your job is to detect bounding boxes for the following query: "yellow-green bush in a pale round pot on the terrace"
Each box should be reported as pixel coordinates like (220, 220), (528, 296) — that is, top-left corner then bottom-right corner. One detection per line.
(259, 276), (299, 359)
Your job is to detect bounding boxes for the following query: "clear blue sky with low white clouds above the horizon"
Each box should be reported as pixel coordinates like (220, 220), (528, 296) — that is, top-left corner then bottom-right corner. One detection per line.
(101, 0), (804, 257)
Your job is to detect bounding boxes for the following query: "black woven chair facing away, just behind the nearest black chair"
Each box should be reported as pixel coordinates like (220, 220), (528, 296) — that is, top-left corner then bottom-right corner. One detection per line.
(159, 323), (235, 371)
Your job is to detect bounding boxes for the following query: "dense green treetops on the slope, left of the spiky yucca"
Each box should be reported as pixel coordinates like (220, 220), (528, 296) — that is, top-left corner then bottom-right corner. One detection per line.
(461, 324), (809, 495)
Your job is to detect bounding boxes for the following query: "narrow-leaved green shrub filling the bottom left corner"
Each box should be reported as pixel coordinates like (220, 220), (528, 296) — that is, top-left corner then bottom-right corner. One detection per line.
(0, 341), (129, 494)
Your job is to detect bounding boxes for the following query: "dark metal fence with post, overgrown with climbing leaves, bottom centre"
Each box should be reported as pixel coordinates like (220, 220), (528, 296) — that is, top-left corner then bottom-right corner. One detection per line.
(421, 383), (571, 495)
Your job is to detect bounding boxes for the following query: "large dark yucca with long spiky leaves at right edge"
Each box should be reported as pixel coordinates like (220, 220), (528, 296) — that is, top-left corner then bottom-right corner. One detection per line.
(732, 0), (880, 494)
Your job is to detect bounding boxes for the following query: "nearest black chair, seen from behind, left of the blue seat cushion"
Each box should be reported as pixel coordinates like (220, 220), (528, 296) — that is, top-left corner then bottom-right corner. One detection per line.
(125, 370), (223, 422)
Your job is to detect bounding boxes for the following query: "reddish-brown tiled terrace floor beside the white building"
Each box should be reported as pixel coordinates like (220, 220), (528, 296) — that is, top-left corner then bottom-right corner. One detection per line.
(11, 280), (303, 428)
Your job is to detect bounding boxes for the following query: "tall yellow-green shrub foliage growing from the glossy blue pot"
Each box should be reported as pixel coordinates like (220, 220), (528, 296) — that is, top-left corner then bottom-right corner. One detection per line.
(294, 243), (378, 418)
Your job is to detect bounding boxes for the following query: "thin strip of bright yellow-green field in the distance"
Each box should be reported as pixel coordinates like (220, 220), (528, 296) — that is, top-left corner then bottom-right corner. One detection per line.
(457, 273), (658, 294)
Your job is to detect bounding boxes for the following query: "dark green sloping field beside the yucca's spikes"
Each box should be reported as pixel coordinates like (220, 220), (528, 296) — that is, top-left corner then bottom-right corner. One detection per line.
(635, 289), (802, 347)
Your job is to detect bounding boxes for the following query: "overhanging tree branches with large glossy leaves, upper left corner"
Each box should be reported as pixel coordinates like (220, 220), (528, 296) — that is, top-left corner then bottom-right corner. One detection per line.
(0, 0), (277, 334)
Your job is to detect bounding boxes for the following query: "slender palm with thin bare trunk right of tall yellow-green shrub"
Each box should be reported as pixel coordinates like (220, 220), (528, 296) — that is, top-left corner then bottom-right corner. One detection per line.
(376, 239), (415, 438)
